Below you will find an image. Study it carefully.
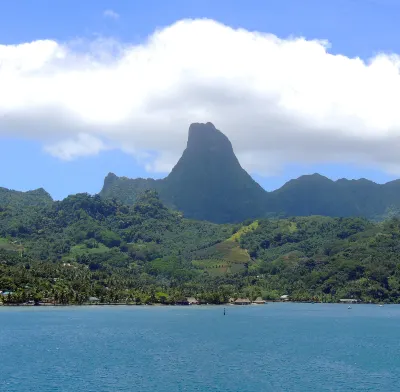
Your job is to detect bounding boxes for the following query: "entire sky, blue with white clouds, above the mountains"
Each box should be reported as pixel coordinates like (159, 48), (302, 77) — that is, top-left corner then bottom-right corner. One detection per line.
(0, 0), (400, 199)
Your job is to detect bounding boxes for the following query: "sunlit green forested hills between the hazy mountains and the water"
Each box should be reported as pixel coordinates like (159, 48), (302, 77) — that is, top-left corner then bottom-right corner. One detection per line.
(0, 191), (400, 304)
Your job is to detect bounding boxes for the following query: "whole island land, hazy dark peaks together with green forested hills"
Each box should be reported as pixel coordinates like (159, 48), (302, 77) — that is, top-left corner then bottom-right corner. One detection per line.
(0, 123), (400, 304)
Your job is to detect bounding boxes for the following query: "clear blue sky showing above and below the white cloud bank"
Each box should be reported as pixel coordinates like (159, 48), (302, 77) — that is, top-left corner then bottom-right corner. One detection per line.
(0, 0), (400, 199)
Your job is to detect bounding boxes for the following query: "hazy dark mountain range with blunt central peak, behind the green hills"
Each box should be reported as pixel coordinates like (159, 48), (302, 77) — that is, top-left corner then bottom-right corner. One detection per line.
(100, 123), (400, 223)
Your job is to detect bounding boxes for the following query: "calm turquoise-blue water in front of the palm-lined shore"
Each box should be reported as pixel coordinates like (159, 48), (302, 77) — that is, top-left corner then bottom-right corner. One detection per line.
(0, 304), (400, 392)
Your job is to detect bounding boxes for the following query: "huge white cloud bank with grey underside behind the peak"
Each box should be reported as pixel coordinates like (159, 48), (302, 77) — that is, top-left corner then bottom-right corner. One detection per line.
(0, 19), (400, 175)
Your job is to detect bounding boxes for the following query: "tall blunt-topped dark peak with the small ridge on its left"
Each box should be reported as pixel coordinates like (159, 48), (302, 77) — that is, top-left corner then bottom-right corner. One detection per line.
(100, 123), (267, 223)
